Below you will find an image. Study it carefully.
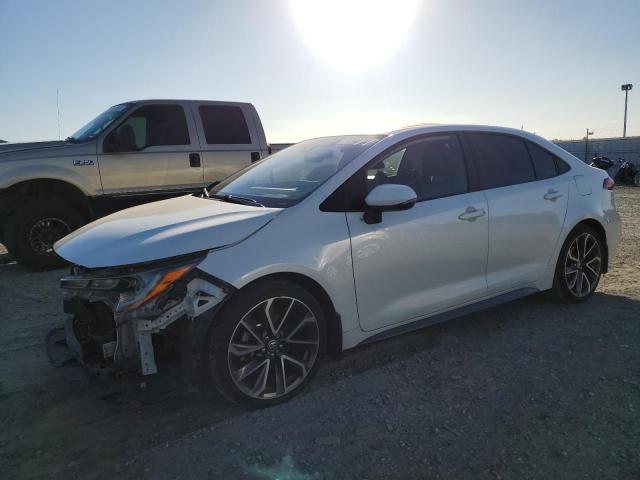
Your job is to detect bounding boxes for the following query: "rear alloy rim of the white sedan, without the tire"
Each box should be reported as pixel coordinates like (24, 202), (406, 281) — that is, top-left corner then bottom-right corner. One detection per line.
(564, 233), (602, 297)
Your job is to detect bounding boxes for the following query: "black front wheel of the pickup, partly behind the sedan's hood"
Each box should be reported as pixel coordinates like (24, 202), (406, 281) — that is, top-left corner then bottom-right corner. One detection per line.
(5, 200), (84, 270)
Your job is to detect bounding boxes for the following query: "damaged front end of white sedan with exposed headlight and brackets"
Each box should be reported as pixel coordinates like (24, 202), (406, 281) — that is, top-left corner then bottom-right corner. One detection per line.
(61, 254), (233, 375)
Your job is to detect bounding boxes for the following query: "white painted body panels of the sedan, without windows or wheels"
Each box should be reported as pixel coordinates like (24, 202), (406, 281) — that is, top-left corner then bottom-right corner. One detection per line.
(56, 125), (620, 348)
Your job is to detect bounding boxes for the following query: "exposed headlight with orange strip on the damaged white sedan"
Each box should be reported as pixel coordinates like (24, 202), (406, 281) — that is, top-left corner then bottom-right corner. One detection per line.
(60, 257), (202, 316)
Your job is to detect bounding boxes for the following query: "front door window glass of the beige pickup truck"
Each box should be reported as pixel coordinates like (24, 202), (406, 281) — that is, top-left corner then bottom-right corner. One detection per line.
(118, 105), (191, 148)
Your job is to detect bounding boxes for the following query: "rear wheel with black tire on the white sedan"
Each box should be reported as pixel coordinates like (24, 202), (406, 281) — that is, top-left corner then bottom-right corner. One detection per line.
(552, 225), (604, 303)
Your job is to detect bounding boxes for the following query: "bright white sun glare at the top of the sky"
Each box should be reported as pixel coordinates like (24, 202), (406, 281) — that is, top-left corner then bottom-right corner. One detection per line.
(289, 0), (420, 72)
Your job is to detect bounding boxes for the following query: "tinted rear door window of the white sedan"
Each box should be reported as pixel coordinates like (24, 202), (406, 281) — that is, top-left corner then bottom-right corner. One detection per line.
(468, 133), (536, 189)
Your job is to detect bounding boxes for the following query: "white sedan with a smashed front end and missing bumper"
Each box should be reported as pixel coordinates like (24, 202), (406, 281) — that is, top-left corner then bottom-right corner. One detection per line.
(56, 125), (620, 405)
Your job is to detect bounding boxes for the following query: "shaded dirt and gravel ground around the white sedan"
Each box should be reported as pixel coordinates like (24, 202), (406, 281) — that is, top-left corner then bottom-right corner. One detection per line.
(0, 188), (640, 480)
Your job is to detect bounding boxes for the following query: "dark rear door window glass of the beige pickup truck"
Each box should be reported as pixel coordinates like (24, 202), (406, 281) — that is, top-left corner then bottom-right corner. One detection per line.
(198, 105), (251, 145)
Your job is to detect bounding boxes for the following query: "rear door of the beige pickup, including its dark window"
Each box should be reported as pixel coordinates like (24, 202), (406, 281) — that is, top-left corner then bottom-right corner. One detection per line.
(191, 102), (266, 185)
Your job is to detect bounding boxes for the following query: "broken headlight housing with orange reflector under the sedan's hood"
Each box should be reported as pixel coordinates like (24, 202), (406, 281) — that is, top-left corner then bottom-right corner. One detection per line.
(60, 255), (204, 317)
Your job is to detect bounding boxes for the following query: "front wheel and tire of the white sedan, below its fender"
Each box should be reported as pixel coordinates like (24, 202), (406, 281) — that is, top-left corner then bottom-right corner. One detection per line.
(203, 279), (326, 407)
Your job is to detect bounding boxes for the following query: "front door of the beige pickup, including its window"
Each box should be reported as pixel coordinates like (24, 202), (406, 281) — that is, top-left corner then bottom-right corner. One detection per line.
(98, 102), (203, 195)
